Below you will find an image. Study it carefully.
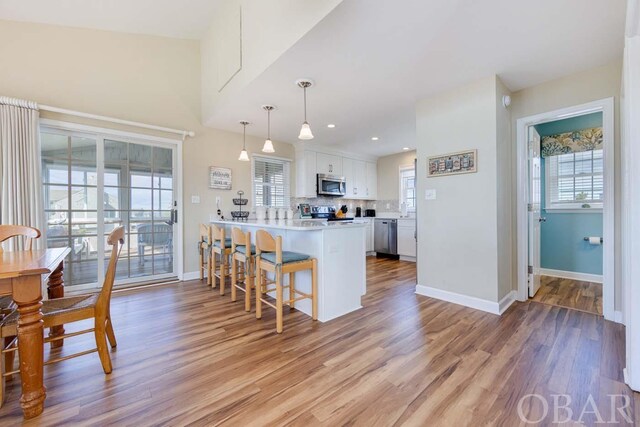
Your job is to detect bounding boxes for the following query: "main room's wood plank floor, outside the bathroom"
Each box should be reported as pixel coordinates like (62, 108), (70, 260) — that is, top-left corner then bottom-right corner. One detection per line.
(0, 259), (640, 427)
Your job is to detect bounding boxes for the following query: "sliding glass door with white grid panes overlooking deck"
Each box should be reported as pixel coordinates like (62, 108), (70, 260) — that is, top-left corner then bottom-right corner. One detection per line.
(41, 127), (178, 289)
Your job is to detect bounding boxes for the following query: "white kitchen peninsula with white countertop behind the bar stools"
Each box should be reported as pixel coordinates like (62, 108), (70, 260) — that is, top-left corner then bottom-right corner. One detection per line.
(211, 219), (367, 322)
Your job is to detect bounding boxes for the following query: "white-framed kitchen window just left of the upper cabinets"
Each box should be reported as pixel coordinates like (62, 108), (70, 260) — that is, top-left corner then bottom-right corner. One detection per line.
(251, 156), (291, 208)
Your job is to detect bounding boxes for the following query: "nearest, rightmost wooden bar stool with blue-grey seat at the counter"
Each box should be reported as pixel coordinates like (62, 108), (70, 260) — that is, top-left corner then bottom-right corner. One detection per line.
(256, 230), (318, 334)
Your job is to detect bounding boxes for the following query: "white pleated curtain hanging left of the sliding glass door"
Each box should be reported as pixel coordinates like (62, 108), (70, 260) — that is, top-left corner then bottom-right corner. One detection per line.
(0, 97), (44, 250)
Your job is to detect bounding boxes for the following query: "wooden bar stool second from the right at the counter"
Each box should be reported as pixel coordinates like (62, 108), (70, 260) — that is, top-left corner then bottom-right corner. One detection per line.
(231, 227), (256, 311)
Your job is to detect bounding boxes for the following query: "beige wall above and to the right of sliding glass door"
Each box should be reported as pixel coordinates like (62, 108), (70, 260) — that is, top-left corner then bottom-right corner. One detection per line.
(0, 21), (294, 272)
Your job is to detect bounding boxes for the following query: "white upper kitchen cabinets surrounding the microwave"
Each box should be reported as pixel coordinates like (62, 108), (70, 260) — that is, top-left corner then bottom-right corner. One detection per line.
(296, 150), (378, 200)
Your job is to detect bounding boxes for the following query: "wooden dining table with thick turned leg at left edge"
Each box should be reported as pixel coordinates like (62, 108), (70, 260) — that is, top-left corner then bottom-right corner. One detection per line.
(0, 247), (71, 419)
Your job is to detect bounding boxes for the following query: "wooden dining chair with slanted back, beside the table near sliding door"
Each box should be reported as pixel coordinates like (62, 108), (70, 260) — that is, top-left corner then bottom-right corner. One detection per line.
(0, 227), (124, 405)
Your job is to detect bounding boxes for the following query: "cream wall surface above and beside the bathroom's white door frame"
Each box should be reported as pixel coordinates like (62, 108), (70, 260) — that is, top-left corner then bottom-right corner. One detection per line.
(511, 58), (622, 310)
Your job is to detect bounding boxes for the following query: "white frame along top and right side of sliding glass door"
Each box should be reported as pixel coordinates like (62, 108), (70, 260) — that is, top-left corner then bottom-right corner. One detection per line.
(39, 118), (184, 284)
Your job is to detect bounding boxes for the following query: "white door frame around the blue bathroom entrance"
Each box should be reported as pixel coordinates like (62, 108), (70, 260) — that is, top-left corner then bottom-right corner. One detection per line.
(516, 97), (622, 322)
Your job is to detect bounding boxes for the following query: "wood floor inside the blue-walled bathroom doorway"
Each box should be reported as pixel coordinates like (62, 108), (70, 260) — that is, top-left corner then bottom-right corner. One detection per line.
(533, 276), (602, 316)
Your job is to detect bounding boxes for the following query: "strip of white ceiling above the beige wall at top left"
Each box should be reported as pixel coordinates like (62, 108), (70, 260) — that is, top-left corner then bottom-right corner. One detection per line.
(0, 0), (218, 39)
